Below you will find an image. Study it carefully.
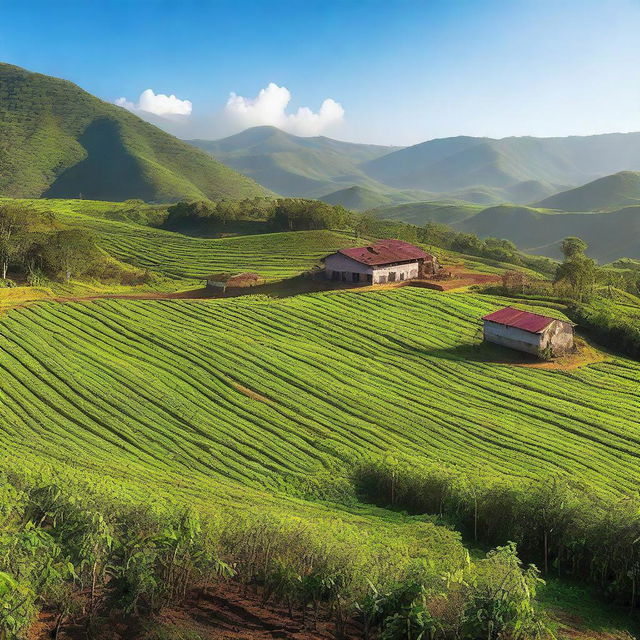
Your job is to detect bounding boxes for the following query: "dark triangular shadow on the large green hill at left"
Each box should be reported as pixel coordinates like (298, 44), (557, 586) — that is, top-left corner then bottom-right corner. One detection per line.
(43, 117), (155, 201)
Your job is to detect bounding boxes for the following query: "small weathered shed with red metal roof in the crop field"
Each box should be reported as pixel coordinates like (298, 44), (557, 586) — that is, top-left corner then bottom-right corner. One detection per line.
(482, 307), (573, 357)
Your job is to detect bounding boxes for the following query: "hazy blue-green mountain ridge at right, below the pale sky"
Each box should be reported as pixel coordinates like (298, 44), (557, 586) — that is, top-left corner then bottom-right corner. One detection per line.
(360, 133), (640, 195)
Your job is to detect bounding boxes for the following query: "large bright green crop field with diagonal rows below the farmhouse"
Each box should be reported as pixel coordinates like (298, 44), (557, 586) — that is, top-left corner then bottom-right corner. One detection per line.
(0, 288), (640, 500)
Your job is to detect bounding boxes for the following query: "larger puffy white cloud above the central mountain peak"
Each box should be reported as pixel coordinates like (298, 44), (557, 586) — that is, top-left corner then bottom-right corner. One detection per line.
(224, 82), (344, 136)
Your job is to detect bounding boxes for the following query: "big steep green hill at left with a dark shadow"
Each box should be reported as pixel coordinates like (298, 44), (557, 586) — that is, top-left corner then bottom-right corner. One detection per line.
(0, 63), (268, 202)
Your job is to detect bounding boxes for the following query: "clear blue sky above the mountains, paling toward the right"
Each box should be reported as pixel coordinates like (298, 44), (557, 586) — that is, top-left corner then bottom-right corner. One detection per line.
(0, 0), (640, 144)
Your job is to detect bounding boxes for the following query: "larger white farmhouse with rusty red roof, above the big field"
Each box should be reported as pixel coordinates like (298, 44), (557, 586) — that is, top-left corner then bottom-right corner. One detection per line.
(324, 240), (441, 284)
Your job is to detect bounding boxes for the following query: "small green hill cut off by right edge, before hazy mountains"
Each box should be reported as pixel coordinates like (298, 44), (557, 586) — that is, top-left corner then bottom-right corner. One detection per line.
(537, 171), (640, 211)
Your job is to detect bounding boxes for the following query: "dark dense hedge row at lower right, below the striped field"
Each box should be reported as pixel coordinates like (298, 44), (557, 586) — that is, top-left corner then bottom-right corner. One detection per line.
(353, 457), (640, 609)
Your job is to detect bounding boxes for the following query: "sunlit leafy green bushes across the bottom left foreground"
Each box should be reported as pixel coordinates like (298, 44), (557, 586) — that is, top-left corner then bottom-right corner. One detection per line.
(0, 473), (548, 640)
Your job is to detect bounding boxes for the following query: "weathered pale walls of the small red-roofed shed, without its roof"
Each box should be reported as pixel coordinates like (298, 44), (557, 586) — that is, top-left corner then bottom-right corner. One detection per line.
(484, 320), (573, 355)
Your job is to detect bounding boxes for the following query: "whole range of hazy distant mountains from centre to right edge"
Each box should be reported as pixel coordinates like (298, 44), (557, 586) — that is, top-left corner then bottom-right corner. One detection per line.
(190, 127), (640, 206)
